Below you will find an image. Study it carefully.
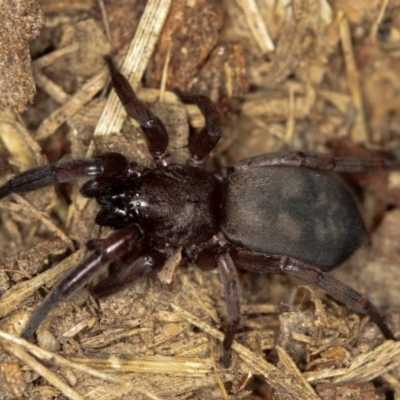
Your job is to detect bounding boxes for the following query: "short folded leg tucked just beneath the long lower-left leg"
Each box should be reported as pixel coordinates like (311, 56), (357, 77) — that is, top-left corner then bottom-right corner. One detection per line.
(92, 250), (166, 297)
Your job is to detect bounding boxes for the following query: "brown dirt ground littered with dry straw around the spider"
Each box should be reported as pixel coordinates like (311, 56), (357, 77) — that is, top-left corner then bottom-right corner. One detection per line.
(0, 0), (400, 400)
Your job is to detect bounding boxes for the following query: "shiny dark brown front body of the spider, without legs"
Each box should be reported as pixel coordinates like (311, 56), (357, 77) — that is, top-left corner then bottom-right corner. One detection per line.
(82, 165), (221, 246)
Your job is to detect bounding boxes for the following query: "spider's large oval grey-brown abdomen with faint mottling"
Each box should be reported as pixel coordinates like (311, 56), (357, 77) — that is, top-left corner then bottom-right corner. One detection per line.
(221, 167), (366, 271)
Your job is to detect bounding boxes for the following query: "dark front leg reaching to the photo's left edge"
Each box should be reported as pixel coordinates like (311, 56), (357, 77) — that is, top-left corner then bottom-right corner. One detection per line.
(0, 153), (128, 199)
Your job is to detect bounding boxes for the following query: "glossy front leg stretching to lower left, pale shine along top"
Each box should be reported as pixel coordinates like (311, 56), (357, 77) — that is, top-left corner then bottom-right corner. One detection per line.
(22, 225), (142, 339)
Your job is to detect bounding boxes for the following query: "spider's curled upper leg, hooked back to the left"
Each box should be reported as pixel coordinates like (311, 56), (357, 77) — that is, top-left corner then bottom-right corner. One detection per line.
(175, 90), (222, 167)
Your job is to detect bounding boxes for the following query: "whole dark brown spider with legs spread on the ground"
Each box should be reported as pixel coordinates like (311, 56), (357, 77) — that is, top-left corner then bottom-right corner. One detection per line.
(0, 57), (400, 367)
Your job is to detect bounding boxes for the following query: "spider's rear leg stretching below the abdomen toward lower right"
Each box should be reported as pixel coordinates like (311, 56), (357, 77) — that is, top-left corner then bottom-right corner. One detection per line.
(230, 247), (396, 340)
